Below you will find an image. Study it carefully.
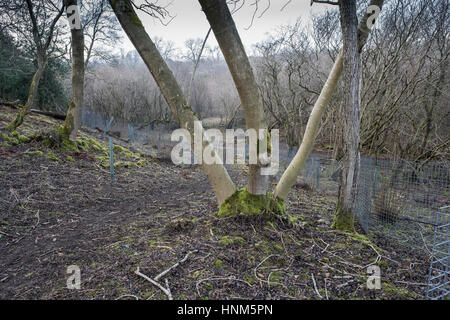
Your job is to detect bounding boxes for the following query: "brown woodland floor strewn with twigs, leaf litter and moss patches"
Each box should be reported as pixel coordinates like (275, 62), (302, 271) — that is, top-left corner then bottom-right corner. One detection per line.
(0, 107), (429, 299)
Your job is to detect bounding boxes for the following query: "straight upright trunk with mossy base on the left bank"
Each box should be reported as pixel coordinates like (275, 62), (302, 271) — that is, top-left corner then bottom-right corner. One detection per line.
(64, 0), (84, 141)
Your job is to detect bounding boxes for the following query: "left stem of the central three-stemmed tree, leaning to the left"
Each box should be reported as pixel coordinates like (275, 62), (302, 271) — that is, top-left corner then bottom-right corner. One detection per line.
(109, 0), (236, 204)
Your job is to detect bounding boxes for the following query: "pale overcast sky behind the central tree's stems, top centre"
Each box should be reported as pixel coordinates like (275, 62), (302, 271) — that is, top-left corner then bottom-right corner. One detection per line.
(119, 0), (337, 51)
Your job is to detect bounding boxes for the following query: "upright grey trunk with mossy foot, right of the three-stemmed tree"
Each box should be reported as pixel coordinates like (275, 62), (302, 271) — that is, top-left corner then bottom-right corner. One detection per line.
(333, 0), (360, 232)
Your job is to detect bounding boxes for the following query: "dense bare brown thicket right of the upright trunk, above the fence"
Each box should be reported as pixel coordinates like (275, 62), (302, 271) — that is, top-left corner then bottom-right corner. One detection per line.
(361, 0), (450, 163)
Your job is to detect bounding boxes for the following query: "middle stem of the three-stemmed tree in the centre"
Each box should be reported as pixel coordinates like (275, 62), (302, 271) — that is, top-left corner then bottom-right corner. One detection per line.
(199, 0), (269, 195)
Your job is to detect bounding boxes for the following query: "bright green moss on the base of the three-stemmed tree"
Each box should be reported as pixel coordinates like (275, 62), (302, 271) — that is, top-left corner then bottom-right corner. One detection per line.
(218, 188), (285, 218)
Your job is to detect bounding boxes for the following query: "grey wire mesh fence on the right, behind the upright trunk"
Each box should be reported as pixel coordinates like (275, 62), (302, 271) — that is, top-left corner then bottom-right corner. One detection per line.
(300, 156), (450, 254)
